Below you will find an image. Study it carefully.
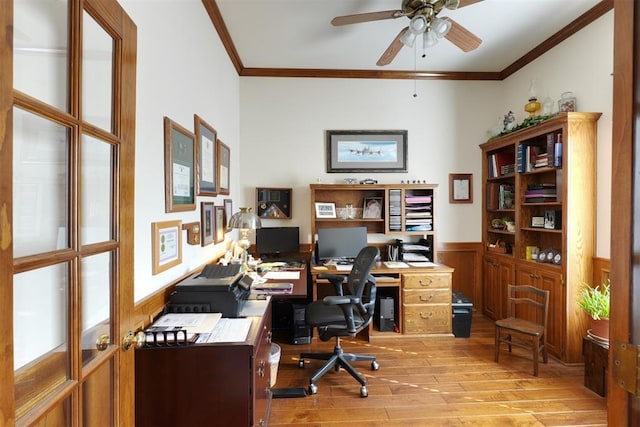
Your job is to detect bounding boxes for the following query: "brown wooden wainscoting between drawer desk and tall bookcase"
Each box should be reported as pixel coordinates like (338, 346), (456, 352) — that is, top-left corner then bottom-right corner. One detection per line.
(436, 242), (483, 313)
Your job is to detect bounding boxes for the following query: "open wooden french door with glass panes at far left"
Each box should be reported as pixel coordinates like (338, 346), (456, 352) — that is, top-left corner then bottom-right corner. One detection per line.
(0, 0), (136, 426)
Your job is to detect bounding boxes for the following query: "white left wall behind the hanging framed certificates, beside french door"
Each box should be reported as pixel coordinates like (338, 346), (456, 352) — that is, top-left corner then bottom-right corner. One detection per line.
(121, 0), (240, 301)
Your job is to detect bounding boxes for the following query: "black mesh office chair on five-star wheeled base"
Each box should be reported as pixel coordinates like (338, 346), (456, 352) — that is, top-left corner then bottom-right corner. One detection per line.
(299, 246), (380, 397)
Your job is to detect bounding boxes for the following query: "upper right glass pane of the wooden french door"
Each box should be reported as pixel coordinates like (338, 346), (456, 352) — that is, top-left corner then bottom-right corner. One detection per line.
(82, 12), (114, 132)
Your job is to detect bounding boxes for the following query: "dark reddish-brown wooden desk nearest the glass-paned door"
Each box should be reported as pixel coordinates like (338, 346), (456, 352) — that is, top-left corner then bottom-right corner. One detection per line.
(135, 299), (271, 427)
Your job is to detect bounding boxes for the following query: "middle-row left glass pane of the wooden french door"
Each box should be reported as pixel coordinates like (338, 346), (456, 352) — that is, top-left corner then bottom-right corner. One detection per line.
(13, 108), (70, 258)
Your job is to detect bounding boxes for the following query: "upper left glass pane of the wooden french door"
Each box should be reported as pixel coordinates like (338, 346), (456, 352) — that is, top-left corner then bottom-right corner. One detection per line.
(13, 0), (69, 111)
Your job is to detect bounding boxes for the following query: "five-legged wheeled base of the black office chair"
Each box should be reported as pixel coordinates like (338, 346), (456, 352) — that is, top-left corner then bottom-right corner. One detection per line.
(298, 344), (380, 397)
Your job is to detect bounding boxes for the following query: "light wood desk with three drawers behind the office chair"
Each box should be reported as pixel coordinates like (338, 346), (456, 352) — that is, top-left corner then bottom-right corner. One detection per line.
(311, 262), (454, 340)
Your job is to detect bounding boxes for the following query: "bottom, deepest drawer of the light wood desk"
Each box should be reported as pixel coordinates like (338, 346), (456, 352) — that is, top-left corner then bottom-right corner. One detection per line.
(404, 303), (451, 334)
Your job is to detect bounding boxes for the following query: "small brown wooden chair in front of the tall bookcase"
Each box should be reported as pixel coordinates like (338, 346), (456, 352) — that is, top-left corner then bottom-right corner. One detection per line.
(495, 285), (549, 377)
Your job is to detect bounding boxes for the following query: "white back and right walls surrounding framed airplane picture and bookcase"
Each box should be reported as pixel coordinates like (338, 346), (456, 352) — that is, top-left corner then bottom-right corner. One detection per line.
(240, 12), (613, 257)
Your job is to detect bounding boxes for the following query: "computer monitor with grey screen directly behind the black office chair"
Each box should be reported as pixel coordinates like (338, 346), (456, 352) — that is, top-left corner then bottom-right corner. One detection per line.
(317, 227), (367, 261)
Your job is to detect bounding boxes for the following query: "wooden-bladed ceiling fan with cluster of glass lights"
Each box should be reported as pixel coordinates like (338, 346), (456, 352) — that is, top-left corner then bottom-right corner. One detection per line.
(331, 0), (482, 66)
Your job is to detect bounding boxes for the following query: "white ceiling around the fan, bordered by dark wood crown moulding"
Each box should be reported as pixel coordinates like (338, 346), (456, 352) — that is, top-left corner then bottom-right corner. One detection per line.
(216, 0), (600, 72)
